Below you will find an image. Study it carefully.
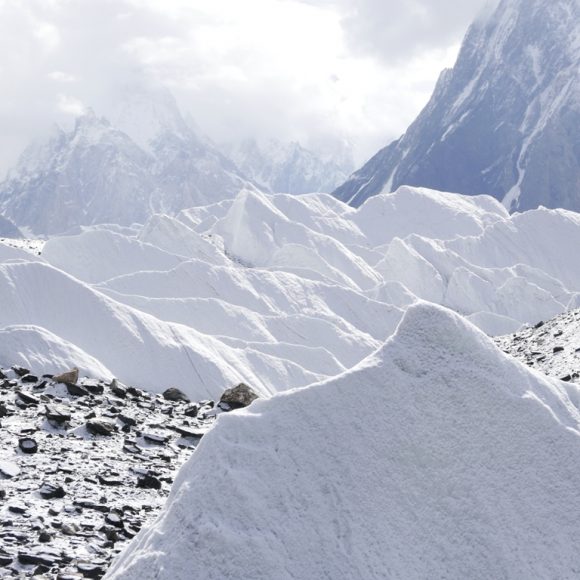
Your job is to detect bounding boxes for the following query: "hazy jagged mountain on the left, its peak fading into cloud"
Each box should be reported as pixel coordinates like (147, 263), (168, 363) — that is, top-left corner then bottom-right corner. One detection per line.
(0, 90), (254, 234)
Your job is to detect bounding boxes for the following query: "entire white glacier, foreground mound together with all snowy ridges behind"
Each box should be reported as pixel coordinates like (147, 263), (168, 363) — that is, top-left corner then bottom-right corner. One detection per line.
(0, 187), (580, 580)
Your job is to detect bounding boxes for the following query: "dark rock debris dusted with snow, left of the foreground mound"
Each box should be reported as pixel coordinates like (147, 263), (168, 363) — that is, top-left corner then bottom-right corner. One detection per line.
(0, 367), (254, 580)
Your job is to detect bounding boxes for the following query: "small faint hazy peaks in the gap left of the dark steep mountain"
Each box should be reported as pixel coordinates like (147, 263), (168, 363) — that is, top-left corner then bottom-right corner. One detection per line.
(227, 139), (353, 194)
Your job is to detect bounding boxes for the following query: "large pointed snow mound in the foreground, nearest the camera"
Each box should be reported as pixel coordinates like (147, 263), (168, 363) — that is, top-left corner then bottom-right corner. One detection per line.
(108, 303), (580, 580)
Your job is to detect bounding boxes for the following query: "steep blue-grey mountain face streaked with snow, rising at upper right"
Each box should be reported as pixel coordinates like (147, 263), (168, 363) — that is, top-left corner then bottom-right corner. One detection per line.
(334, 0), (580, 211)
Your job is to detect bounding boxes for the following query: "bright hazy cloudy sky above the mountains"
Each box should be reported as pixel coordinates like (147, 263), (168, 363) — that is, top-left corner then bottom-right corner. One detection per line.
(0, 0), (498, 171)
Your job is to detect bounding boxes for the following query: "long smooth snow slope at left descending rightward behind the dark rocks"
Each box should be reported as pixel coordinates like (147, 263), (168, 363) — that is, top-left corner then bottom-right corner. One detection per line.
(0, 262), (321, 397)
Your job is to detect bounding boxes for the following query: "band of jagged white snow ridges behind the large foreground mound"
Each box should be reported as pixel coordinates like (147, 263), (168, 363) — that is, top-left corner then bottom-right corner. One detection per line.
(0, 187), (580, 399)
